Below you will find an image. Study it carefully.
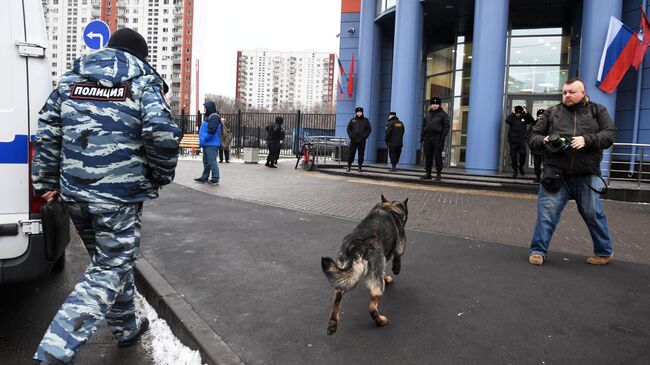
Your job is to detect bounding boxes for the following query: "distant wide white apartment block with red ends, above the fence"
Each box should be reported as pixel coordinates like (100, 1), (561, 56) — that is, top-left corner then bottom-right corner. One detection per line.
(236, 50), (335, 110)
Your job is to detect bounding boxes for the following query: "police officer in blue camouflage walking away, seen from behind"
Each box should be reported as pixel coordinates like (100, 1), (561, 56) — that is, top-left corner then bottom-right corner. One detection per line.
(32, 28), (180, 364)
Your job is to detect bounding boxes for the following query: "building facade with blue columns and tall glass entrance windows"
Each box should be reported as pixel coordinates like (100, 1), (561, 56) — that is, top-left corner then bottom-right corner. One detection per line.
(337, 0), (650, 173)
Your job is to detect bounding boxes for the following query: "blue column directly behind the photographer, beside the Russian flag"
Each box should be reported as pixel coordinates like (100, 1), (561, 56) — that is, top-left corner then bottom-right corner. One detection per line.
(580, 0), (623, 176)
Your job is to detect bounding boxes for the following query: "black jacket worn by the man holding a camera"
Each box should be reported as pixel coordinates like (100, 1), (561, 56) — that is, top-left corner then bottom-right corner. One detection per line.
(529, 97), (616, 175)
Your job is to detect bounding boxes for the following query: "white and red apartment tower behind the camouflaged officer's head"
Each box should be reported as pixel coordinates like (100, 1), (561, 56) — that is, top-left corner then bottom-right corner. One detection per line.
(43, 0), (194, 113)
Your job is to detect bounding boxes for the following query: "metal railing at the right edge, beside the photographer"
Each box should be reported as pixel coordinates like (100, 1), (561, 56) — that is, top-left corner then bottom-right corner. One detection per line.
(607, 143), (650, 189)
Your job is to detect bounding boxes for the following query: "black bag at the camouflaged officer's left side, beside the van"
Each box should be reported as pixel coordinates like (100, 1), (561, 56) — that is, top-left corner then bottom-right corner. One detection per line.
(41, 195), (70, 261)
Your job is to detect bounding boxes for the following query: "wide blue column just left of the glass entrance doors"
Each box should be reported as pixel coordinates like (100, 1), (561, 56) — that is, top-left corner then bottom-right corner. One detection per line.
(465, 0), (509, 174)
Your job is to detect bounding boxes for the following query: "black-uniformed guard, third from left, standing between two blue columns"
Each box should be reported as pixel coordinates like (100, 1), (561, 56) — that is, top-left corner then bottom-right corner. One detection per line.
(420, 97), (449, 181)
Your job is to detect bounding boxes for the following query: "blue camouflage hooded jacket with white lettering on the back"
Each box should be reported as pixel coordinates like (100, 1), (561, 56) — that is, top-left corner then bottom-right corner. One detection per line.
(32, 48), (180, 204)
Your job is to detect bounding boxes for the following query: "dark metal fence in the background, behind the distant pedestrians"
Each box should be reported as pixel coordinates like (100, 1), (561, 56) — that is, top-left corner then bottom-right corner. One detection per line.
(174, 110), (336, 156)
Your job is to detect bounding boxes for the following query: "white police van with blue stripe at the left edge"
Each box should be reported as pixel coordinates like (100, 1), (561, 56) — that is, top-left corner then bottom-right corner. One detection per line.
(0, 0), (69, 285)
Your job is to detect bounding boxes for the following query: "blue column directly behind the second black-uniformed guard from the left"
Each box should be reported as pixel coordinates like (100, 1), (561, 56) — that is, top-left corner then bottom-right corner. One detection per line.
(384, 0), (422, 165)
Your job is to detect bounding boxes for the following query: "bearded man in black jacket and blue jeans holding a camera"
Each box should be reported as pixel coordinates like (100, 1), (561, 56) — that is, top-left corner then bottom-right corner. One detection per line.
(528, 78), (616, 265)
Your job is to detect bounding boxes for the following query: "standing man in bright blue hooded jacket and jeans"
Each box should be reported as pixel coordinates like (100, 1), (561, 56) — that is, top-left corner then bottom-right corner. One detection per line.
(194, 101), (223, 185)
